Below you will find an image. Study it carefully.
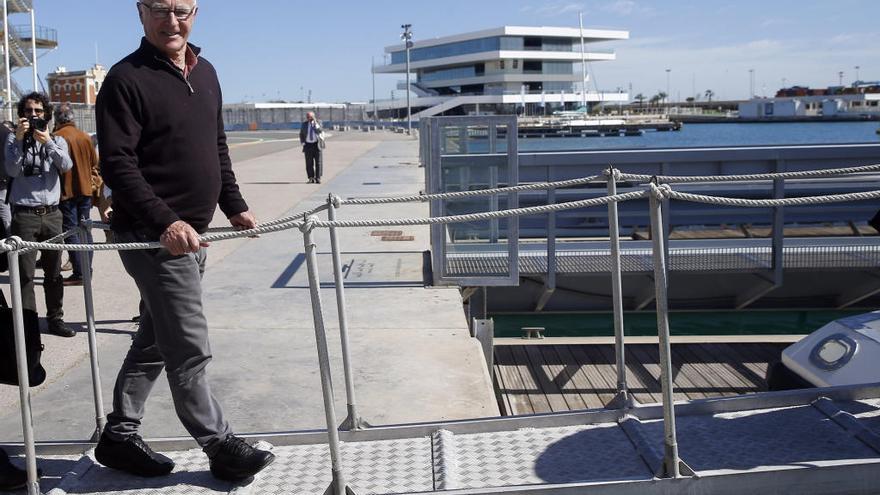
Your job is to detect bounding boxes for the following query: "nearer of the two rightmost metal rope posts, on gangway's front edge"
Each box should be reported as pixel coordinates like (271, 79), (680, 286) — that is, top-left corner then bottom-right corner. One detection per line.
(651, 184), (681, 478)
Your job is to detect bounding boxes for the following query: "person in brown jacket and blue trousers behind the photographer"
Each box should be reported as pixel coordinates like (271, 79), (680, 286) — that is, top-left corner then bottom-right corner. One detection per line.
(54, 103), (103, 285)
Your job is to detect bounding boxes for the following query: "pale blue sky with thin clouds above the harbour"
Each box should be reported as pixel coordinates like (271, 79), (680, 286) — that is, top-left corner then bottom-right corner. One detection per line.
(22, 0), (880, 102)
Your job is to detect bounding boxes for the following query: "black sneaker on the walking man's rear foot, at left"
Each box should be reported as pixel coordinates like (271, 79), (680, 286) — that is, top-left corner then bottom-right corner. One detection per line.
(95, 435), (174, 478)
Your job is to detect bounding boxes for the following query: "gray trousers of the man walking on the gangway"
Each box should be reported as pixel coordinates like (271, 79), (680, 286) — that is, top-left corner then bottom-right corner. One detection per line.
(105, 232), (230, 455)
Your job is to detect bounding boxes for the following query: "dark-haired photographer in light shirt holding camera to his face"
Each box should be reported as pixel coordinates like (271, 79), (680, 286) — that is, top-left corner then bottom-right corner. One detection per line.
(4, 92), (76, 337)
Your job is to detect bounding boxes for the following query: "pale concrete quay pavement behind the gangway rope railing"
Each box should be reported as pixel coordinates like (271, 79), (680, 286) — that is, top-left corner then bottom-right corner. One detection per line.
(0, 132), (498, 442)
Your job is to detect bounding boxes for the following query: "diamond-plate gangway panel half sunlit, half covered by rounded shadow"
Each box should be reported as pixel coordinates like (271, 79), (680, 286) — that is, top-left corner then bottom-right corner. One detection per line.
(446, 424), (652, 489)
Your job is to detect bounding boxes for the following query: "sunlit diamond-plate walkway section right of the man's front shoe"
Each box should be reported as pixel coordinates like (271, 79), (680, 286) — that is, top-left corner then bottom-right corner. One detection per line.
(252, 437), (434, 495)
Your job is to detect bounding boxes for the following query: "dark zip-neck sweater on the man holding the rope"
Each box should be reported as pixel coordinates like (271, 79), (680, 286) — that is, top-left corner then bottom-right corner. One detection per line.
(95, 38), (248, 239)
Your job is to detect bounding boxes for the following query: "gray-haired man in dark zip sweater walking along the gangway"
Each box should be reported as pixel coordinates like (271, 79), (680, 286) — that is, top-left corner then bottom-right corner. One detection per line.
(95, 0), (274, 481)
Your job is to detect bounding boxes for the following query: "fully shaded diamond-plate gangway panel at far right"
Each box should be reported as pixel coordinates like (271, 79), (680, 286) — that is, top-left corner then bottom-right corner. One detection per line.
(642, 406), (877, 471)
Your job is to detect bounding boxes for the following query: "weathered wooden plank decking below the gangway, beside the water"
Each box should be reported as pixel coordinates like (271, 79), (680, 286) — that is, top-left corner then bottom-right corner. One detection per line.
(494, 342), (788, 415)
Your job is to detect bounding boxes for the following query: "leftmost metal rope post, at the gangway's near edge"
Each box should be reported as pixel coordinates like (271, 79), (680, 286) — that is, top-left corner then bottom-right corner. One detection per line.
(7, 251), (40, 495)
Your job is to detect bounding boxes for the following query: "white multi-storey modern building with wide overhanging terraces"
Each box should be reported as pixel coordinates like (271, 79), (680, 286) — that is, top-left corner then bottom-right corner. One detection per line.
(367, 26), (629, 119)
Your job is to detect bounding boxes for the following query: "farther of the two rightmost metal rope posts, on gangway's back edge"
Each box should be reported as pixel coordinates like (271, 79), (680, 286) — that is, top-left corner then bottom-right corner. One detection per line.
(608, 167), (632, 408)
